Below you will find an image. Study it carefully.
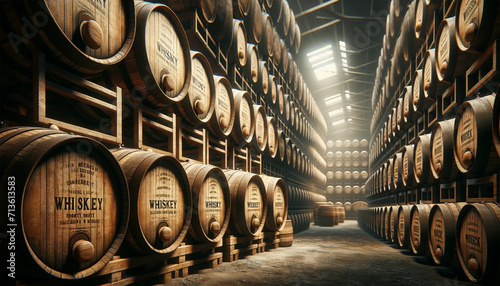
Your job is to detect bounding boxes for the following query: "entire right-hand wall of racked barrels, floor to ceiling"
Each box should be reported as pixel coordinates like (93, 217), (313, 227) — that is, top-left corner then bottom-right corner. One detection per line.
(359, 0), (500, 283)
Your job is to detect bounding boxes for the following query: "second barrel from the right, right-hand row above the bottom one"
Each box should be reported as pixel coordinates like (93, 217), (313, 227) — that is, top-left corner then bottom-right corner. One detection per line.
(431, 118), (460, 181)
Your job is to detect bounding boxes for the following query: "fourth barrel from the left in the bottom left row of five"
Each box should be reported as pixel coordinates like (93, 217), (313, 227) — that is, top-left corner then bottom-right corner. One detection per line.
(224, 170), (267, 236)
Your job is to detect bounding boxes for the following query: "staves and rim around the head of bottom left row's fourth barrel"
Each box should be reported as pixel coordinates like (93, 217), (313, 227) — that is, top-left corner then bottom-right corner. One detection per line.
(224, 170), (267, 236)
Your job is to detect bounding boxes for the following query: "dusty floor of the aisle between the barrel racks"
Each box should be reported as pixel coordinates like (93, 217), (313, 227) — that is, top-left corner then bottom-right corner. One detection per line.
(162, 221), (474, 285)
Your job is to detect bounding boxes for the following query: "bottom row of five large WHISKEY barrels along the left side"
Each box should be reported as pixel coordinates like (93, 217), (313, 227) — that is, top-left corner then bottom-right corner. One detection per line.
(0, 127), (288, 279)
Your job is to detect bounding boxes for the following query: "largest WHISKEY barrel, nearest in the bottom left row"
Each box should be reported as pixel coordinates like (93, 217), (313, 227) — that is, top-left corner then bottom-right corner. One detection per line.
(0, 127), (129, 279)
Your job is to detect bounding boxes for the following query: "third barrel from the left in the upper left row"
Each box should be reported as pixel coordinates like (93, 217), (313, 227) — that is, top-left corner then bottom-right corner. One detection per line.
(176, 51), (215, 126)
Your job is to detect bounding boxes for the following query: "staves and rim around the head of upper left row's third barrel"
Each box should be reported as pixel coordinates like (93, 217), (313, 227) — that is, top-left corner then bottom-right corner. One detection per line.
(174, 51), (215, 126)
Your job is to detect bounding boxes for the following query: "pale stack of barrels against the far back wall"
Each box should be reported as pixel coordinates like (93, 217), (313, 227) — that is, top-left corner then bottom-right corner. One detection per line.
(326, 139), (368, 218)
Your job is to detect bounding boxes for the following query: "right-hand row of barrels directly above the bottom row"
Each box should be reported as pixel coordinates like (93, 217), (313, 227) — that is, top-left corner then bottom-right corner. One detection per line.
(367, 92), (500, 195)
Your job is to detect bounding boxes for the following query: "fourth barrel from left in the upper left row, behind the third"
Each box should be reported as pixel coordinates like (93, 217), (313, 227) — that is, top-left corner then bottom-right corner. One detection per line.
(208, 76), (235, 138)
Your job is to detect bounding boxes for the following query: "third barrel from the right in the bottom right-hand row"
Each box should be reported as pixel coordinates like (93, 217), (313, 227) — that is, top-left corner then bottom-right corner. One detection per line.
(410, 204), (432, 255)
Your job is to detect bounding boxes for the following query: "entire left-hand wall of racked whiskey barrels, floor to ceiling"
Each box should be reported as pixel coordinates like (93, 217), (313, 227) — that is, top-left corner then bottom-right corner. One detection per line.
(0, 0), (334, 279)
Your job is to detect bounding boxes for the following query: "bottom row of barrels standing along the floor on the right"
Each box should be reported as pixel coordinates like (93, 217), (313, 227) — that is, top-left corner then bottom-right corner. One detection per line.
(358, 203), (500, 285)
